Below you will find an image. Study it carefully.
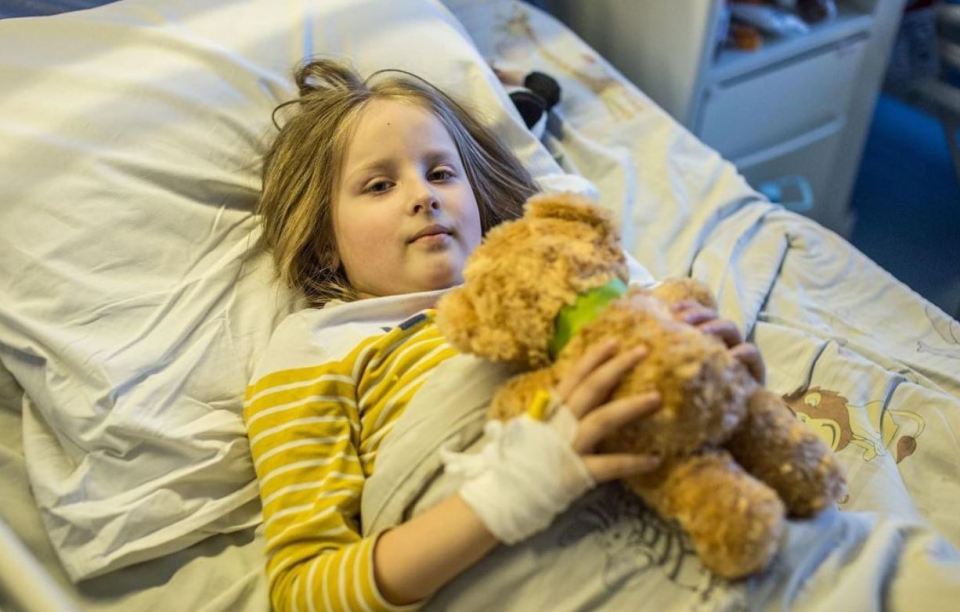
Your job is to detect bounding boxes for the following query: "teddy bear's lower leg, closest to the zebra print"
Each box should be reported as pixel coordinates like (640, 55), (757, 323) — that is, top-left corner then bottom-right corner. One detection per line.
(628, 451), (784, 579)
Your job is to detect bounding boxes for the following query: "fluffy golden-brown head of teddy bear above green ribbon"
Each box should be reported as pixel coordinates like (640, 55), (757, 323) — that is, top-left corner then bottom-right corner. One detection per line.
(437, 194), (628, 368)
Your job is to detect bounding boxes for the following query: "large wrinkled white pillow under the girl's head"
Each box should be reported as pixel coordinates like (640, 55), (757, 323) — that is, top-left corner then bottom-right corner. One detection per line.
(0, 0), (559, 580)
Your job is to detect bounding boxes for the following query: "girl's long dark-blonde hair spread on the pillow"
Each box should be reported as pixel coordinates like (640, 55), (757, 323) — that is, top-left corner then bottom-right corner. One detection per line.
(257, 60), (537, 306)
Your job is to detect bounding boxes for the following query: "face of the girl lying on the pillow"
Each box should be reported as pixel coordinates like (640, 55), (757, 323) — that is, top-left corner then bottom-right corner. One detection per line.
(333, 100), (481, 297)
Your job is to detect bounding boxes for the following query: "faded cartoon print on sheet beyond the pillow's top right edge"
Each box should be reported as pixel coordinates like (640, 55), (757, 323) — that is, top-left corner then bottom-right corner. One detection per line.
(498, 4), (642, 119)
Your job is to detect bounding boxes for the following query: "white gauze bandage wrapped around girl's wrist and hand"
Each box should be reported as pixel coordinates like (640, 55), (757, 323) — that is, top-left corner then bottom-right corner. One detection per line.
(440, 407), (596, 544)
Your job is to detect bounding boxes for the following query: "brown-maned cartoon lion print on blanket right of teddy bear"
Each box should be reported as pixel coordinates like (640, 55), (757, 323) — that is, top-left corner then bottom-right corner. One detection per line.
(783, 387), (926, 463)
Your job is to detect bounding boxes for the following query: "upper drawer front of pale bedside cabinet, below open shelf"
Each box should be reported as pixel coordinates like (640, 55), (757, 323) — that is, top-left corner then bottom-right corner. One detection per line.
(697, 36), (866, 162)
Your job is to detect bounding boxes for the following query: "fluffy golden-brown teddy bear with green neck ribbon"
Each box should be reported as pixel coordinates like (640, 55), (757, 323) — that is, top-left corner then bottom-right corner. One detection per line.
(436, 194), (845, 579)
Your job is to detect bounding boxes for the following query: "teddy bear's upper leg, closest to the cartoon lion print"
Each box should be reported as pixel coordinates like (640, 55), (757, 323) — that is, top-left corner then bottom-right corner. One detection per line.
(727, 389), (846, 517)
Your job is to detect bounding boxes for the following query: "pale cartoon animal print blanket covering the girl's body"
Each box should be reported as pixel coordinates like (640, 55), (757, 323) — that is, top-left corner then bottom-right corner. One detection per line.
(362, 203), (960, 610)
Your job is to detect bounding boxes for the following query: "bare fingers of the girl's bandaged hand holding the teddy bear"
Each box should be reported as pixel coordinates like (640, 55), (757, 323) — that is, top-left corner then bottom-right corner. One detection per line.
(556, 339), (660, 483)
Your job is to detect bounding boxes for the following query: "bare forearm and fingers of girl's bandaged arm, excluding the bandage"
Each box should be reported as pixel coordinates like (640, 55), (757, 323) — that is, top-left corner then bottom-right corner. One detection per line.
(373, 343), (659, 605)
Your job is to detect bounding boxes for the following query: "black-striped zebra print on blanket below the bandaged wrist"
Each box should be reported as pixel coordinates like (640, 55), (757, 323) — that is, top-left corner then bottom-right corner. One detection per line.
(558, 483), (723, 598)
